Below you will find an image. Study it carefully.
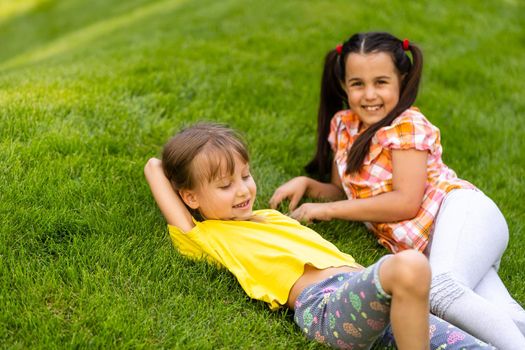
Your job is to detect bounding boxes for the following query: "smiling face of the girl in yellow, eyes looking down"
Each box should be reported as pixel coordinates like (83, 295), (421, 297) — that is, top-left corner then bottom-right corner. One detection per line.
(181, 154), (257, 220)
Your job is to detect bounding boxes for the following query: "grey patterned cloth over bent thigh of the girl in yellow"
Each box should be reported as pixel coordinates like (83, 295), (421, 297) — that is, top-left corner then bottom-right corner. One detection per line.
(294, 259), (391, 348)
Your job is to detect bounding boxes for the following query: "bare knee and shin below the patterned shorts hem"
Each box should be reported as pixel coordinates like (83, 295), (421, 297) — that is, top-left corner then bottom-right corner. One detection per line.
(379, 250), (430, 349)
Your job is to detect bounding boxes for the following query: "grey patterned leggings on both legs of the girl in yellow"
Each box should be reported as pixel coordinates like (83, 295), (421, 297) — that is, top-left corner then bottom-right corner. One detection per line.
(294, 256), (493, 350)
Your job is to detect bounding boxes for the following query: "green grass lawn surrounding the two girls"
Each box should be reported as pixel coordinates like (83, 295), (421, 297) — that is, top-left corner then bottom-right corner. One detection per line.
(0, 0), (525, 349)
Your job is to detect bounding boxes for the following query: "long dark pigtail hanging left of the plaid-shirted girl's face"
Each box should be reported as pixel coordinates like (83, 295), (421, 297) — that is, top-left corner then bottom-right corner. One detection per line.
(305, 50), (346, 179)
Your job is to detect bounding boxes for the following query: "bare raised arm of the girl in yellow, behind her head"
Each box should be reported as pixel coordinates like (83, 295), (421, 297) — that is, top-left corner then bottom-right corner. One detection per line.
(144, 158), (195, 232)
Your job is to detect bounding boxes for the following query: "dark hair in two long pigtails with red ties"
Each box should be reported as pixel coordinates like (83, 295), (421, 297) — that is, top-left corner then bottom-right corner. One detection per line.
(305, 32), (423, 179)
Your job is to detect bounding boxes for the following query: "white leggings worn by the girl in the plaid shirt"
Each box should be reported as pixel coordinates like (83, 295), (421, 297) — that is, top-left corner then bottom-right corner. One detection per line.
(428, 189), (525, 350)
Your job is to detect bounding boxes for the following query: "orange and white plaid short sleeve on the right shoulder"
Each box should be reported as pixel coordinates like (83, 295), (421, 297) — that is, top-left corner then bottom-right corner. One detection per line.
(376, 111), (439, 153)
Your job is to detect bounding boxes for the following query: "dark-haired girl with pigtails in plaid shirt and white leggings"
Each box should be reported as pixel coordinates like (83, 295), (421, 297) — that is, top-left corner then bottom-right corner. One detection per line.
(270, 32), (525, 349)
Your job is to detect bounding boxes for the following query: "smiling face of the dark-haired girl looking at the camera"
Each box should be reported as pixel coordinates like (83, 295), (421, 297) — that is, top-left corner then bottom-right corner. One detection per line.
(344, 52), (401, 128)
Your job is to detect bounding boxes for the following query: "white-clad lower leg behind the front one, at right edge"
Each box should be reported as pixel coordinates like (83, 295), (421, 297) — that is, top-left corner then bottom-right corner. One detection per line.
(474, 268), (525, 335)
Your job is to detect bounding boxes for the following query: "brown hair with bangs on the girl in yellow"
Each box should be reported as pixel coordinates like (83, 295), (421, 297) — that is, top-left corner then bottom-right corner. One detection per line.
(162, 123), (249, 190)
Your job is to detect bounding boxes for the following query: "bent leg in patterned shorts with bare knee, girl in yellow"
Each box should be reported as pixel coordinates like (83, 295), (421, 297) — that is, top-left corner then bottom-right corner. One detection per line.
(294, 251), (430, 350)
